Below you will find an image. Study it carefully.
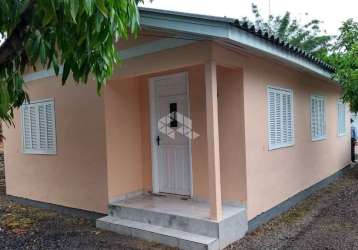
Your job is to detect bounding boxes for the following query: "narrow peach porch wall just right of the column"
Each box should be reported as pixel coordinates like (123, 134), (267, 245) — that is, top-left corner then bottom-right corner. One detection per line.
(218, 67), (247, 203)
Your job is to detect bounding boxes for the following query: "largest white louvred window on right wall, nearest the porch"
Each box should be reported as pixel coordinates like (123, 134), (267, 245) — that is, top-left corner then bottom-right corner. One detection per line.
(267, 87), (294, 150)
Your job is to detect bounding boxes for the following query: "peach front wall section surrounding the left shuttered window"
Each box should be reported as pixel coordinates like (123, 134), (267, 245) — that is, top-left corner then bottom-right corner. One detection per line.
(4, 77), (108, 212)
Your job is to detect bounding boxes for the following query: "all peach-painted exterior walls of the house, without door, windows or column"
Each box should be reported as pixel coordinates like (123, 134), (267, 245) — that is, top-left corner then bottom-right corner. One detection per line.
(4, 35), (349, 219)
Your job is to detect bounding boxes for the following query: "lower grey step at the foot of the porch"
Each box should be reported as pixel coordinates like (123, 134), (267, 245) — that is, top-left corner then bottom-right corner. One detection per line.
(96, 216), (219, 250)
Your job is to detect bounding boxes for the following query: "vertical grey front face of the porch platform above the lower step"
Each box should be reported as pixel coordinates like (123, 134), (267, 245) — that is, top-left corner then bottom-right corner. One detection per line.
(109, 204), (219, 238)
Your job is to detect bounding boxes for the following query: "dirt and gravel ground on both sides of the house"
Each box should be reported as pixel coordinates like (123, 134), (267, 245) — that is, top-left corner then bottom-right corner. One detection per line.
(0, 164), (358, 250)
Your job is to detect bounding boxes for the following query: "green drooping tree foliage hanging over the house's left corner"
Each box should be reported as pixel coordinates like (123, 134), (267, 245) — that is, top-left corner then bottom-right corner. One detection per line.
(0, 0), (139, 124)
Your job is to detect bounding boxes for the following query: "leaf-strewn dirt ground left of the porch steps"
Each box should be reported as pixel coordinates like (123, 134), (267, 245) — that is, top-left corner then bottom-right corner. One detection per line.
(0, 197), (171, 250)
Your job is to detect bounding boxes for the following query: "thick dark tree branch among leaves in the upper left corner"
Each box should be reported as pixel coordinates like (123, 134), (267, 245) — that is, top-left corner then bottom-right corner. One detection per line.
(0, 0), (36, 67)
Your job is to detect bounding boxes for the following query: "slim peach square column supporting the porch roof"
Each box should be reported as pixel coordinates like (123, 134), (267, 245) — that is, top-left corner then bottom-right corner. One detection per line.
(205, 61), (222, 221)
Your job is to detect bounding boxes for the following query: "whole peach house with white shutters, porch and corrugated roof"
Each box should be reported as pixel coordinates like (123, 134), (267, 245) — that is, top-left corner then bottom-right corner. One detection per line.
(5, 9), (350, 249)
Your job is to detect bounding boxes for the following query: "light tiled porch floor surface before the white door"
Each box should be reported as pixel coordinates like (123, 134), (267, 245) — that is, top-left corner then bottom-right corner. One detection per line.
(111, 194), (245, 220)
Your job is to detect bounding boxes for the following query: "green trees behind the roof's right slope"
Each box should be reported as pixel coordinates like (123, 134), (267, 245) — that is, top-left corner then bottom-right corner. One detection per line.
(242, 5), (358, 112)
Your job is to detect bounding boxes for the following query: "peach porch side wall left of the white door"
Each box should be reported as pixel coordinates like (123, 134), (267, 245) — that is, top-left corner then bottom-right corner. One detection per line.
(104, 78), (148, 200)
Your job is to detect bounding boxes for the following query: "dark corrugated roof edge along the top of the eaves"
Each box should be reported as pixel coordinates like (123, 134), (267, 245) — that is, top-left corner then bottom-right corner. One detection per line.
(139, 7), (335, 73)
